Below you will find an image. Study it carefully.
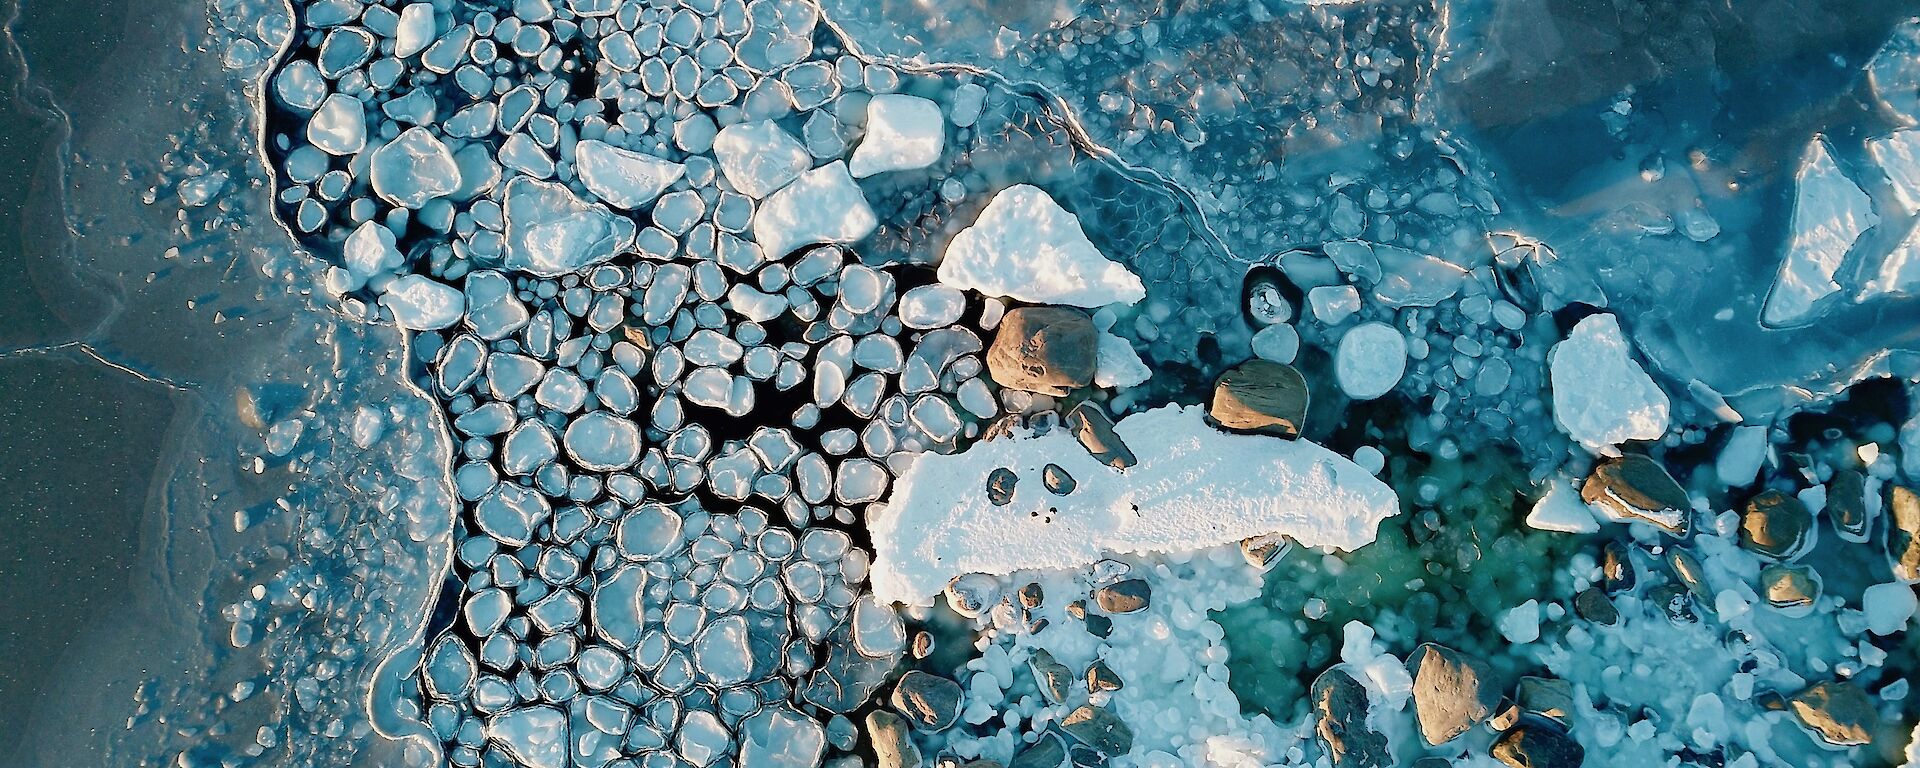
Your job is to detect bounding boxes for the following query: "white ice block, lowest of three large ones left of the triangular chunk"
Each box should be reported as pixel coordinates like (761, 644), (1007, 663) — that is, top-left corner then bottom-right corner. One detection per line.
(753, 161), (879, 259)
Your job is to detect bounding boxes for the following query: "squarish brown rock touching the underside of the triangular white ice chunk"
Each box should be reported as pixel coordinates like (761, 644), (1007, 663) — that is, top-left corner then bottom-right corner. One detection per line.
(987, 307), (1096, 397)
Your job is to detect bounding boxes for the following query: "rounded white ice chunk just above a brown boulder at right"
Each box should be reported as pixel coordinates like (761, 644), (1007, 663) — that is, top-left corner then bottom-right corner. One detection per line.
(1548, 313), (1670, 449)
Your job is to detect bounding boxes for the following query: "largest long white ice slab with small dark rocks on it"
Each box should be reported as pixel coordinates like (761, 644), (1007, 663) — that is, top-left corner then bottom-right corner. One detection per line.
(868, 405), (1400, 603)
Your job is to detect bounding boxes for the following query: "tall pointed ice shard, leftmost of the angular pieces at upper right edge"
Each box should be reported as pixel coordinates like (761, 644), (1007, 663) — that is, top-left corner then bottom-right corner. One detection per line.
(1761, 136), (1880, 326)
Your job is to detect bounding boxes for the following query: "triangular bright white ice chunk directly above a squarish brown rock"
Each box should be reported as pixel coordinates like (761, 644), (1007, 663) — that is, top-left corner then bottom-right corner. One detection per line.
(939, 184), (1146, 307)
